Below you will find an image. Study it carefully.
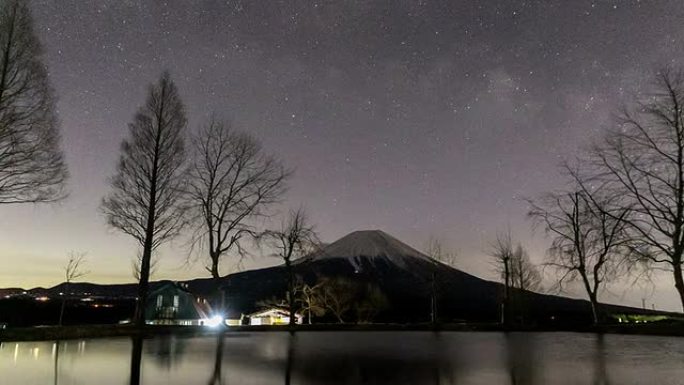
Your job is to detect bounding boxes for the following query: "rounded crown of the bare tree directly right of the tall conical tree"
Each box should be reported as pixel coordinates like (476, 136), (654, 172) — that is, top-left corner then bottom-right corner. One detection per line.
(189, 121), (290, 279)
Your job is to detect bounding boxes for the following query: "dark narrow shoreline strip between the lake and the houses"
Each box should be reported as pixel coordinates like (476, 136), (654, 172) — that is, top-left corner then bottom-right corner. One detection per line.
(0, 323), (684, 342)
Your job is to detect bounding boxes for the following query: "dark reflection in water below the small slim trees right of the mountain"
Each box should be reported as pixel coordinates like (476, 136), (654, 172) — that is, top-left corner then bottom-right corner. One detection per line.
(505, 333), (536, 385)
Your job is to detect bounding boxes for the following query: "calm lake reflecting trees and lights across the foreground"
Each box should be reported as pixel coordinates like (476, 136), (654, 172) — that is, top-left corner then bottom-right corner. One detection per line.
(0, 332), (684, 385)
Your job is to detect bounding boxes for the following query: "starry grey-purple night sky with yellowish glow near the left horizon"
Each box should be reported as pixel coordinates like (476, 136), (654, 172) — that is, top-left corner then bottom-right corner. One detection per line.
(0, 0), (684, 309)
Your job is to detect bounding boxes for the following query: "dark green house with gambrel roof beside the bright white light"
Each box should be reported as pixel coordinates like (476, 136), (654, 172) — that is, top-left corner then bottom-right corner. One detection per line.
(145, 281), (215, 325)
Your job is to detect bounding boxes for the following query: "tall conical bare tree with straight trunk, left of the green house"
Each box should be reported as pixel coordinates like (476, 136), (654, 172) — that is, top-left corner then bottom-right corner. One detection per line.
(102, 73), (186, 326)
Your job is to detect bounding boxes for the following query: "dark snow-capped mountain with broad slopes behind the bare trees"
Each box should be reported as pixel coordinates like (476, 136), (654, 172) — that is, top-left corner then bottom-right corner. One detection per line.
(220, 230), (672, 324)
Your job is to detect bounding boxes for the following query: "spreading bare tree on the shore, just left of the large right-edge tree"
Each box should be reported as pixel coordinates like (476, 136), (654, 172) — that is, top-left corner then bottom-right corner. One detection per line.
(528, 191), (630, 323)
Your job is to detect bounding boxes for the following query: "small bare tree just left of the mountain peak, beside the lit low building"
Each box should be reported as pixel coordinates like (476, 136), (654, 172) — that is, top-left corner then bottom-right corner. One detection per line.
(260, 208), (319, 325)
